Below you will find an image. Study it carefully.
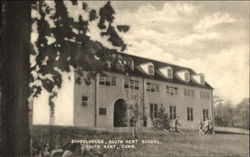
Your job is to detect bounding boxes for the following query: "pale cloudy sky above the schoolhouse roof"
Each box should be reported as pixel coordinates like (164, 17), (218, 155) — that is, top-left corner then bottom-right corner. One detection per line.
(85, 1), (250, 104)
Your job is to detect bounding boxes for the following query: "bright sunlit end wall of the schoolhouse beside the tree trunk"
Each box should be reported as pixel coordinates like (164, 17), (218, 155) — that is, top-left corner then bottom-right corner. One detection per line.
(29, 72), (74, 126)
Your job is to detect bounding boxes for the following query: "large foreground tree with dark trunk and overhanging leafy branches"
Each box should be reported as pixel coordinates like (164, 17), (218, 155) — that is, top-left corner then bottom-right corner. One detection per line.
(0, 1), (129, 157)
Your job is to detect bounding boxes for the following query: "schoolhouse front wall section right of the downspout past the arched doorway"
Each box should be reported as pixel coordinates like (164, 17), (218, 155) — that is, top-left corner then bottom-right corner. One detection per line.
(145, 79), (212, 128)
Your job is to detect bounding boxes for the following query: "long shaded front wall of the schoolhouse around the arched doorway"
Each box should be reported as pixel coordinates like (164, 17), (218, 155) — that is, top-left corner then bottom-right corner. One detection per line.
(74, 72), (212, 128)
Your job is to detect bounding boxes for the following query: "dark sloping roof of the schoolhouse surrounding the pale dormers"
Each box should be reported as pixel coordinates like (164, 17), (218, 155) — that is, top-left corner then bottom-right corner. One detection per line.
(104, 53), (213, 89)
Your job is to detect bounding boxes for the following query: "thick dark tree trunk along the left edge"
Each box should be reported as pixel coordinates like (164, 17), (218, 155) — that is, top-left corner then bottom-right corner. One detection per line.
(1, 0), (31, 157)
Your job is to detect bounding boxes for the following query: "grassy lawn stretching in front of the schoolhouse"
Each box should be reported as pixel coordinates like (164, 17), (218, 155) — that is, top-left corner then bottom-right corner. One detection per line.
(31, 126), (249, 157)
